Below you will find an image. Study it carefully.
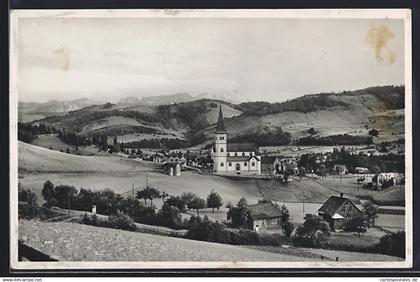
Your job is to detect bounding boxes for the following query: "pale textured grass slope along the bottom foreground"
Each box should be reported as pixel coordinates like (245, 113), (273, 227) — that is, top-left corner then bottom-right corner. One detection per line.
(19, 220), (312, 262)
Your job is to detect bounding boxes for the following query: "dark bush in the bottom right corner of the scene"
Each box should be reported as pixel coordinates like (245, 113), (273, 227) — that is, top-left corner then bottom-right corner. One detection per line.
(375, 231), (405, 258)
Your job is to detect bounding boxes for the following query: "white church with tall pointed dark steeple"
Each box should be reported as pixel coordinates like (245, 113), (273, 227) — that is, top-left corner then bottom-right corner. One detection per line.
(211, 106), (261, 175)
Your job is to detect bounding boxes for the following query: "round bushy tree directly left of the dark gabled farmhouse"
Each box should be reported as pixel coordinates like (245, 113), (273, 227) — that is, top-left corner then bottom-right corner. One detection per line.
(293, 214), (331, 247)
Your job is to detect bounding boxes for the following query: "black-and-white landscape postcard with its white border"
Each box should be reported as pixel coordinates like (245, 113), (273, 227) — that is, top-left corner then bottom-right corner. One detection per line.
(10, 9), (413, 269)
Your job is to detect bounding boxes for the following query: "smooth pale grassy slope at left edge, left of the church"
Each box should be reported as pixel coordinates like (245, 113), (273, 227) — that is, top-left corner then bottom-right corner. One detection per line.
(18, 141), (159, 173)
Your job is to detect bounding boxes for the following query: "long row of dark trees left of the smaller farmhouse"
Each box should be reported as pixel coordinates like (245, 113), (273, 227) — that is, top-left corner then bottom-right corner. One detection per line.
(42, 180), (223, 228)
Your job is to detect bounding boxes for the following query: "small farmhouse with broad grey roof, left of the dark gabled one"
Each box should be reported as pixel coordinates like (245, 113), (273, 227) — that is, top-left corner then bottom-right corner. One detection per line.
(248, 202), (281, 231)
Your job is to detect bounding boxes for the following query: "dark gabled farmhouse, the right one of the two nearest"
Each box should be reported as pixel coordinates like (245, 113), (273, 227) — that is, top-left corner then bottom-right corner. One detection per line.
(318, 193), (362, 231)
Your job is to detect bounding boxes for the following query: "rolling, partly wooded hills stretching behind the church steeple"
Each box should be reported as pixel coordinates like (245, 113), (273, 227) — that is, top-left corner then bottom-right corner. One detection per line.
(18, 86), (404, 148)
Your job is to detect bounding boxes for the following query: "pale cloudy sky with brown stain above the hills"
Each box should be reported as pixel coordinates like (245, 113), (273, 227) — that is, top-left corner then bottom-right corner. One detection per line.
(18, 17), (404, 102)
